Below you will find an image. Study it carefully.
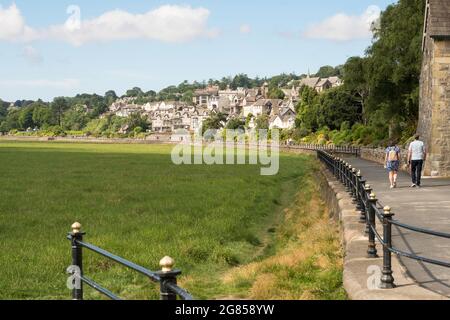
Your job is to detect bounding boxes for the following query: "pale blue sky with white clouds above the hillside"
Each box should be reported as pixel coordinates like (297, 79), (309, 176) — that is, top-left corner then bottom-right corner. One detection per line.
(0, 0), (395, 101)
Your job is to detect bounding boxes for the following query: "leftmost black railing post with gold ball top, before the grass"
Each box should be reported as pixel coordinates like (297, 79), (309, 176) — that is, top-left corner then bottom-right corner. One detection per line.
(69, 222), (85, 300)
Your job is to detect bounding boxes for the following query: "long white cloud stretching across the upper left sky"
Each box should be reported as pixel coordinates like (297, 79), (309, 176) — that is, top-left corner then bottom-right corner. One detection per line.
(0, 4), (218, 46)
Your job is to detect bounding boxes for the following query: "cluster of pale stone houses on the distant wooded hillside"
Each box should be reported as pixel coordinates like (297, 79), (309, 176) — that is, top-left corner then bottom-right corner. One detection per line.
(109, 76), (343, 133)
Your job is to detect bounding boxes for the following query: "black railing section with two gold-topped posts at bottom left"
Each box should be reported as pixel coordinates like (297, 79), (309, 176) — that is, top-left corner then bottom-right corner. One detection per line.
(67, 223), (194, 300)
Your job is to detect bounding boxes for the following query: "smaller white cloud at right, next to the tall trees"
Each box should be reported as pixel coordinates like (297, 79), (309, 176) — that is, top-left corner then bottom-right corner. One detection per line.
(303, 5), (381, 41)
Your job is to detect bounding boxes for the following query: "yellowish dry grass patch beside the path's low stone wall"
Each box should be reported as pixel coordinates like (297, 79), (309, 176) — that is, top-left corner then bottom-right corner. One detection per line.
(223, 173), (346, 300)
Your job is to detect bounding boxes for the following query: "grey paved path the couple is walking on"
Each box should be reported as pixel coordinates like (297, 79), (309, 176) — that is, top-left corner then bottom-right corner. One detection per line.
(346, 157), (450, 297)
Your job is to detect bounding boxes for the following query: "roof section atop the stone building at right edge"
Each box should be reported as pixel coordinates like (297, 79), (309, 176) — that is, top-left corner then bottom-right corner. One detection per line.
(426, 0), (450, 38)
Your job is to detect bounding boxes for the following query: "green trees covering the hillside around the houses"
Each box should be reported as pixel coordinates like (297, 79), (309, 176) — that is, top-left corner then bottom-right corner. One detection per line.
(0, 0), (425, 145)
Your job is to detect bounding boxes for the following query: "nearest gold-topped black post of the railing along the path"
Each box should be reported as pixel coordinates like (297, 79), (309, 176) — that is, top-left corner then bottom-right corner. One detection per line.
(380, 207), (395, 289)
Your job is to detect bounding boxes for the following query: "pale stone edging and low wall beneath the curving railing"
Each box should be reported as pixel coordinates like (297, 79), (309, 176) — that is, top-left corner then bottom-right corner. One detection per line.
(317, 164), (449, 300)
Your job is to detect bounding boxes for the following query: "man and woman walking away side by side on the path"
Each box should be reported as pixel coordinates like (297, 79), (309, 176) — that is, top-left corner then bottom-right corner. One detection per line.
(385, 135), (427, 189)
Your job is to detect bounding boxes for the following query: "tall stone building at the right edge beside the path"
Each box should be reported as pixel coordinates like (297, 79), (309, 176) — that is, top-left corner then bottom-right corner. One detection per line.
(418, 0), (450, 177)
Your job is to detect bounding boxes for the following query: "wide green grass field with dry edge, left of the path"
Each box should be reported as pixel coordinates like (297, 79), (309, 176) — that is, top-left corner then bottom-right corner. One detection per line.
(0, 142), (345, 299)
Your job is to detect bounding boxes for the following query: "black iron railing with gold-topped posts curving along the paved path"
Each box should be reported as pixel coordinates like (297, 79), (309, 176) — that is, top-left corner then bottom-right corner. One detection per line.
(317, 150), (450, 289)
